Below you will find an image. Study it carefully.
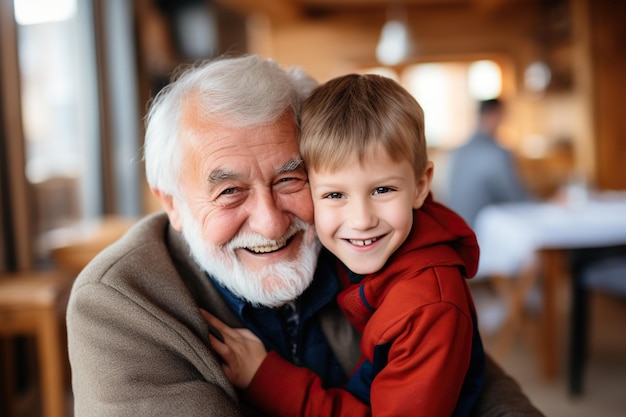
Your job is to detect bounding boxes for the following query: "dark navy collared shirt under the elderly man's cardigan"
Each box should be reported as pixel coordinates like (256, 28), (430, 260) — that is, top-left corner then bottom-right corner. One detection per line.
(211, 249), (347, 388)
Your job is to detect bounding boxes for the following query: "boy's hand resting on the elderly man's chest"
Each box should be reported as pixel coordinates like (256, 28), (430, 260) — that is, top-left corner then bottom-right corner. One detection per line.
(200, 309), (267, 389)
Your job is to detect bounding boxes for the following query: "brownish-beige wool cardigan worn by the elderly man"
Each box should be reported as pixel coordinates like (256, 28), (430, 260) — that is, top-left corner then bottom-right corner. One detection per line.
(67, 213), (541, 417)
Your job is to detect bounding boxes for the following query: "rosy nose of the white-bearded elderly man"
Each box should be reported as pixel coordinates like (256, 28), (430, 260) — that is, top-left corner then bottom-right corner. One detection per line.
(248, 191), (291, 239)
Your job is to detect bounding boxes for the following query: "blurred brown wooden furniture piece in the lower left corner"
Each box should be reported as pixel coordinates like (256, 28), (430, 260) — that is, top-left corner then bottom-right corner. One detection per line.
(0, 271), (73, 417)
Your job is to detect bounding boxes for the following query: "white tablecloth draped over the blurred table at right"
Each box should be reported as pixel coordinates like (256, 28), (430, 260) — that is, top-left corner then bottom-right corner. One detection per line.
(474, 192), (626, 276)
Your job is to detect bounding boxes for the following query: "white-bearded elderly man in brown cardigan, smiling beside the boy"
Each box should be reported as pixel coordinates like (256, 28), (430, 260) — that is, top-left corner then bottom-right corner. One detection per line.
(67, 56), (541, 417)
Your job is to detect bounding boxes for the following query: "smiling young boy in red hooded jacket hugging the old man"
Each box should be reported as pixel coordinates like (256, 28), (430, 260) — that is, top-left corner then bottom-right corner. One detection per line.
(205, 74), (484, 417)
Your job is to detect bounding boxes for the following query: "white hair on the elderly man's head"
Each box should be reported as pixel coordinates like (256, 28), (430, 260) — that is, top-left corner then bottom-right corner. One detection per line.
(144, 55), (317, 196)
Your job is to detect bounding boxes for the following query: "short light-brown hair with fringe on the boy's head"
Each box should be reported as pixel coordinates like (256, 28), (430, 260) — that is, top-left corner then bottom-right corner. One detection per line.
(299, 74), (428, 178)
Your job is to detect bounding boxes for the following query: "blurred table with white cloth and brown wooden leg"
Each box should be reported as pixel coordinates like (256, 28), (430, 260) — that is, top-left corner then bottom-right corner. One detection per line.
(475, 192), (626, 379)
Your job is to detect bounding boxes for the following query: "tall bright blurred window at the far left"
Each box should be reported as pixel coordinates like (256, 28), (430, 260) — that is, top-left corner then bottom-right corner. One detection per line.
(14, 0), (101, 260)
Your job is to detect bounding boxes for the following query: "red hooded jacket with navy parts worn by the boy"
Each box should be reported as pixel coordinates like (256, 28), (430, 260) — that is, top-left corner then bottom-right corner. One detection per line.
(245, 196), (483, 417)
